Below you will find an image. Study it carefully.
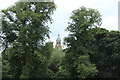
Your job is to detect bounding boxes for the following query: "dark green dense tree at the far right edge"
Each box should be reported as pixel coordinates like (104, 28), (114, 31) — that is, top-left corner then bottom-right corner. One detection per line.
(88, 28), (120, 78)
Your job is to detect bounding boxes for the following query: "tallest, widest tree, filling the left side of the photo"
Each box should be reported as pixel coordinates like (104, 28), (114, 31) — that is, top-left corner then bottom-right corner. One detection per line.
(1, 2), (55, 78)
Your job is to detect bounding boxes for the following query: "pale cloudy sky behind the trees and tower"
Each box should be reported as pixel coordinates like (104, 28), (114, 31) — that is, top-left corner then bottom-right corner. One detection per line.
(0, 0), (120, 45)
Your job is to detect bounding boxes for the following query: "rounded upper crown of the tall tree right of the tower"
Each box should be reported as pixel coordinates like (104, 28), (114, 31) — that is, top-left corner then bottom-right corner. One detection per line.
(67, 7), (101, 35)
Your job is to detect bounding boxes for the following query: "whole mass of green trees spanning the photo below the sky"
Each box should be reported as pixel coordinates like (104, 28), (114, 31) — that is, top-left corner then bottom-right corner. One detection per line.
(0, 2), (120, 79)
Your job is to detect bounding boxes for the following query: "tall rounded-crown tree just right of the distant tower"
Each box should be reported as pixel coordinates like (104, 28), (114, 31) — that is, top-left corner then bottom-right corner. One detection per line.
(64, 7), (101, 78)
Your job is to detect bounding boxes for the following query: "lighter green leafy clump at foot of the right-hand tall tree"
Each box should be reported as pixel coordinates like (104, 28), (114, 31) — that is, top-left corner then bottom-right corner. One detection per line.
(74, 55), (98, 78)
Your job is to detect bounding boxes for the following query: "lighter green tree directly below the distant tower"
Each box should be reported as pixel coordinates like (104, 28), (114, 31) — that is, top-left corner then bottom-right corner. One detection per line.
(48, 48), (65, 78)
